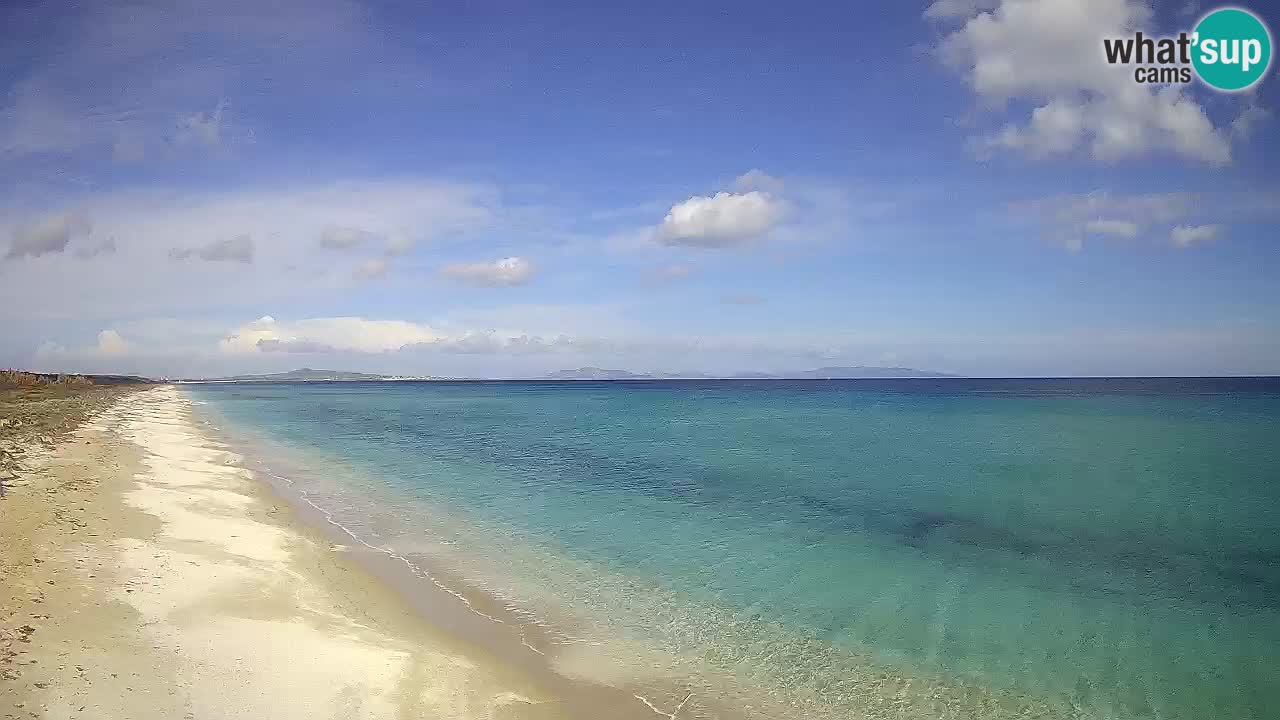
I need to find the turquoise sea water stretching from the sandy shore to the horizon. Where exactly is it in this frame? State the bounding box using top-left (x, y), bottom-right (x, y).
top-left (187, 379), bottom-right (1280, 719)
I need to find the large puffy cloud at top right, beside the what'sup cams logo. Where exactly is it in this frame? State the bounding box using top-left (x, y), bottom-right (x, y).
top-left (925, 0), bottom-right (1231, 165)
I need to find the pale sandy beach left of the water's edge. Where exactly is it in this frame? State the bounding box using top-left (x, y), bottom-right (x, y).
top-left (0, 387), bottom-right (680, 720)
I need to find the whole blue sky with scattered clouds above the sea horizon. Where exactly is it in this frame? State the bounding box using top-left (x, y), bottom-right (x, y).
top-left (0, 0), bottom-right (1280, 377)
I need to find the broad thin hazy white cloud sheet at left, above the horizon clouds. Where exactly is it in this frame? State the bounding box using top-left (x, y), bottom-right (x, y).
top-left (0, 178), bottom-right (503, 322)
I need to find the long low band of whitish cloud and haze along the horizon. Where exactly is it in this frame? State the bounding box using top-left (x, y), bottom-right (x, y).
top-left (22, 306), bottom-right (1280, 377)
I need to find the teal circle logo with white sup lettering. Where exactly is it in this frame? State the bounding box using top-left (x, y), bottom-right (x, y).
top-left (1192, 8), bottom-right (1271, 92)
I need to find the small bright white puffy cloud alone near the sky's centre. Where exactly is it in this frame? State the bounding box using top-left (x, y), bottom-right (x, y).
top-left (657, 190), bottom-right (786, 247)
